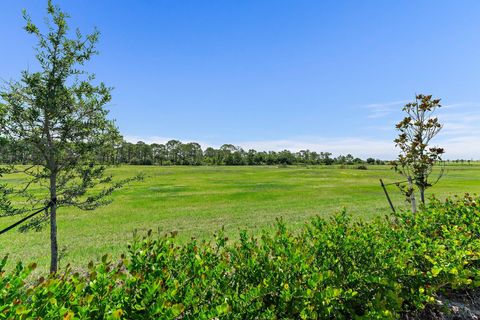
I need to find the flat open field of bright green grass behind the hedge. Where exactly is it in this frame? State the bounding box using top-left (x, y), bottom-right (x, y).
top-left (0, 163), bottom-right (480, 270)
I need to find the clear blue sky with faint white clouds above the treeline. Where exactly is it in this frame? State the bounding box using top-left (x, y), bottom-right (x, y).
top-left (0, 0), bottom-right (480, 158)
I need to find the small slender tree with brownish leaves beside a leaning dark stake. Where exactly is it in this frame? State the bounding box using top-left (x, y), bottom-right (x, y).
top-left (393, 94), bottom-right (444, 212)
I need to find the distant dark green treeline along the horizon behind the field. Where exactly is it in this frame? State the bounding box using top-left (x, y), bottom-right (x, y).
top-left (0, 140), bottom-right (384, 165)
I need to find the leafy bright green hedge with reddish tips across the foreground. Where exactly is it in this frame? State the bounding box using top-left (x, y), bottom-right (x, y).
top-left (0, 195), bottom-right (480, 319)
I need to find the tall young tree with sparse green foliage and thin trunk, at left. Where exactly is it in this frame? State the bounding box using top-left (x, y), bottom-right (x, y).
top-left (0, 1), bottom-right (133, 272)
